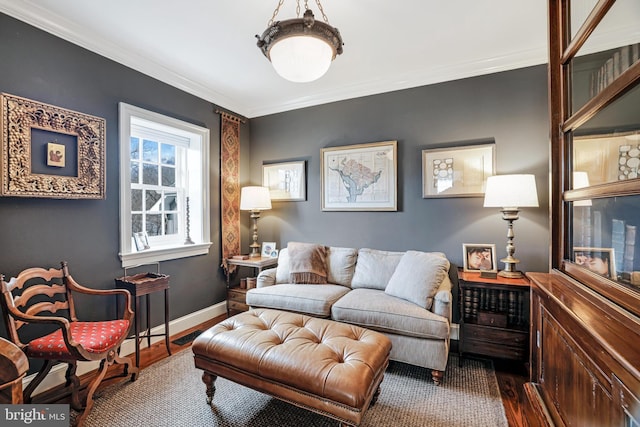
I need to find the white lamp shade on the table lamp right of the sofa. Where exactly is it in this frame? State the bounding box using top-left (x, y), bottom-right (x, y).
top-left (484, 174), bottom-right (538, 208)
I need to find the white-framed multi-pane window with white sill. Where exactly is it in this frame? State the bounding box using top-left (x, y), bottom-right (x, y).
top-left (120, 103), bottom-right (211, 267)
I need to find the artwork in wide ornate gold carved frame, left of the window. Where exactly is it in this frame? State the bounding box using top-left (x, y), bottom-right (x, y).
top-left (0, 93), bottom-right (106, 199)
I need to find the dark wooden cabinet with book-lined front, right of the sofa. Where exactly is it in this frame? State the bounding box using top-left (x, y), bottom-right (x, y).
top-left (458, 270), bottom-right (530, 364)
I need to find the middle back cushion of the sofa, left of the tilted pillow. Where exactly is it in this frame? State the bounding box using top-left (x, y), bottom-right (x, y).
top-left (351, 248), bottom-right (404, 290)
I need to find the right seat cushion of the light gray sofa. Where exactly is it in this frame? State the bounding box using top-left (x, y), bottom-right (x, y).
top-left (332, 289), bottom-right (451, 340)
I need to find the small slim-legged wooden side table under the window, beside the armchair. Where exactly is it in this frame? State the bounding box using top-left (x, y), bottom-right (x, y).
top-left (116, 272), bottom-right (171, 366)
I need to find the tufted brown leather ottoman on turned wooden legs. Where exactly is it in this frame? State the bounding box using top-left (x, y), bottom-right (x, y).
top-left (192, 309), bottom-right (391, 425)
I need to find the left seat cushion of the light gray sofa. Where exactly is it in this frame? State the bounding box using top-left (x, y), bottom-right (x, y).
top-left (247, 284), bottom-right (350, 317)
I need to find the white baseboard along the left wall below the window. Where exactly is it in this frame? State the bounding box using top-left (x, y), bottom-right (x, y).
top-left (22, 302), bottom-right (227, 396)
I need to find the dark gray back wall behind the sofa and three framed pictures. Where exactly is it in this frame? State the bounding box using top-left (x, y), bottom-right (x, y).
top-left (250, 66), bottom-right (549, 288)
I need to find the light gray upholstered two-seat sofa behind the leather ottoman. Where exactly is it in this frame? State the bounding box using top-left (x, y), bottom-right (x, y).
top-left (247, 247), bottom-right (457, 385)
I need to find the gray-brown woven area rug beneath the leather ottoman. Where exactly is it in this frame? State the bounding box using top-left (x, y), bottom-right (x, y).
top-left (85, 349), bottom-right (508, 427)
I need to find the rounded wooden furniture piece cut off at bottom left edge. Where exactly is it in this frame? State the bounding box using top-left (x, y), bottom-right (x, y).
top-left (0, 337), bottom-right (29, 404)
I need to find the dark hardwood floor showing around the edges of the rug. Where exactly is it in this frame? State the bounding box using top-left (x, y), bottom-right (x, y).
top-left (34, 315), bottom-right (528, 427)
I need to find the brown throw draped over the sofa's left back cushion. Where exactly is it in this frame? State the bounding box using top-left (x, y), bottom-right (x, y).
top-left (287, 242), bottom-right (327, 284)
